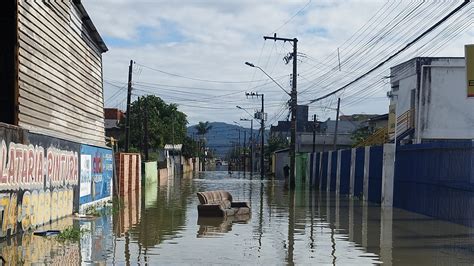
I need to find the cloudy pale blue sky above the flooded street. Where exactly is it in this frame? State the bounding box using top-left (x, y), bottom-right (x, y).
top-left (82, 0), bottom-right (474, 127)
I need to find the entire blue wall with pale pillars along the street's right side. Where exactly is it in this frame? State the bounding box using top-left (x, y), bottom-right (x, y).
top-left (308, 141), bottom-right (474, 226)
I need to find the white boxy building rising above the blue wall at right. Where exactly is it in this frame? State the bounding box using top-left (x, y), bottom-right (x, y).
top-left (391, 58), bottom-right (474, 139)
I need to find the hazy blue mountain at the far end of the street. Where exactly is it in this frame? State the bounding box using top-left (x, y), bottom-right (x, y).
top-left (188, 121), bottom-right (262, 158)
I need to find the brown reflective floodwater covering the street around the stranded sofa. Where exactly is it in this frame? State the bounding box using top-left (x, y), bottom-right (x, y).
top-left (0, 172), bottom-right (474, 265)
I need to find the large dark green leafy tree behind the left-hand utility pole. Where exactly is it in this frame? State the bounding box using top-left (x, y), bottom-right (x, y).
top-left (121, 95), bottom-right (188, 154)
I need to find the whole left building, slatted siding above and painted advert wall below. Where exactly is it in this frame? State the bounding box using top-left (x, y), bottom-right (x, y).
top-left (0, 0), bottom-right (114, 239)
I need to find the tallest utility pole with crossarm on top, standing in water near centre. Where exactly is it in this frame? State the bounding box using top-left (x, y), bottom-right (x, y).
top-left (263, 33), bottom-right (298, 189)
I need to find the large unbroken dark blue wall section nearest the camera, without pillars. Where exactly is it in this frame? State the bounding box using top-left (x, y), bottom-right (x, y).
top-left (394, 141), bottom-right (474, 226)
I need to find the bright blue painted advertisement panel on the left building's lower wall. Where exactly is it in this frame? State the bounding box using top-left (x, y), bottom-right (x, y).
top-left (79, 145), bottom-right (113, 204)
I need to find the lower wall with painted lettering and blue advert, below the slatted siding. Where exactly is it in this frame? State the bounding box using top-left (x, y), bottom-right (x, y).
top-left (0, 123), bottom-right (113, 238)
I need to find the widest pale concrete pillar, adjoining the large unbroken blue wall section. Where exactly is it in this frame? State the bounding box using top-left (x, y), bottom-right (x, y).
top-left (382, 143), bottom-right (395, 207)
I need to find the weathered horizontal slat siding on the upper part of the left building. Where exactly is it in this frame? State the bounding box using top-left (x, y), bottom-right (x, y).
top-left (18, 0), bottom-right (105, 146)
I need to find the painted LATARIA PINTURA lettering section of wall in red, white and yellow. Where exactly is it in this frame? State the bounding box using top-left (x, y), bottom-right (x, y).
top-left (0, 129), bottom-right (80, 238)
